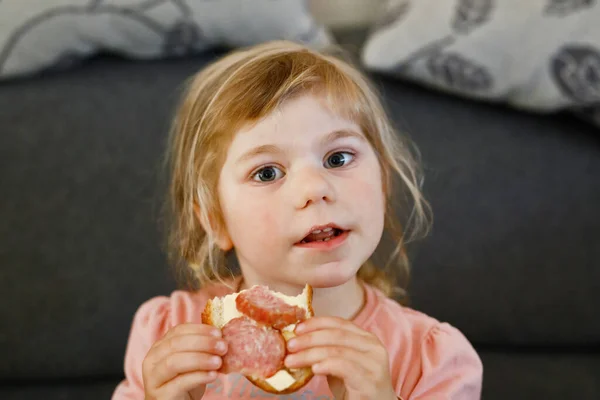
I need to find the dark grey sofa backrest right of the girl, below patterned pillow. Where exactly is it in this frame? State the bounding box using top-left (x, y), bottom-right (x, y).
top-left (379, 74), bottom-right (600, 346)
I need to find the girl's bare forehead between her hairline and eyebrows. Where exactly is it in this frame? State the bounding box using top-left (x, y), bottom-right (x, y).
top-left (230, 95), bottom-right (361, 154)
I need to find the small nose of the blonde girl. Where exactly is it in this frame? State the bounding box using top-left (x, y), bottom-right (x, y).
top-left (292, 168), bottom-right (335, 209)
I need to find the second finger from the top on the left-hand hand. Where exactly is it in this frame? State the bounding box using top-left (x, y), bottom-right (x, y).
top-left (149, 334), bottom-right (227, 362)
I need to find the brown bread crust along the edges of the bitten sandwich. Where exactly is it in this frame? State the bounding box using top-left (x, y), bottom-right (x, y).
top-left (202, 285), bottom-right (315, 394)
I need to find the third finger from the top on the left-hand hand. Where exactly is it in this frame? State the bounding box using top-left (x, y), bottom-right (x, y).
top-left (152, 352), bottom-right (223, 386)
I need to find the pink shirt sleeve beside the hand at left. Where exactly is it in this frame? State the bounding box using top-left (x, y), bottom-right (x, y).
top-left (112, 297), bottom-right (171, 400)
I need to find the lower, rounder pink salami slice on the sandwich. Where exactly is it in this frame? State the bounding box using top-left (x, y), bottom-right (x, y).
top-left (221, 317), bottom-right (285, 379)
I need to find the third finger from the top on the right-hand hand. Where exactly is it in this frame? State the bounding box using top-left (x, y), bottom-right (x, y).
top-left (284, 346), bottom-right (375, 368)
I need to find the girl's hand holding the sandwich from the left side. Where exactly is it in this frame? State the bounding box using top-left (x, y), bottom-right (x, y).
top-left (142, 324), bottom-right (227, 400)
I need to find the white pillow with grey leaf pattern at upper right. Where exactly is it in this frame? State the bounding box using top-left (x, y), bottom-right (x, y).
top-left (362, 0), bottom-right (600, 125)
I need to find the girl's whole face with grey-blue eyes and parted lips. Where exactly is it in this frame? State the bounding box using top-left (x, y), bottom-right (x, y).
top-left (219, 95), bottom-right (385, 288)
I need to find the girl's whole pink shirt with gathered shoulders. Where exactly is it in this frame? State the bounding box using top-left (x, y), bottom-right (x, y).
top-left (112, 285), bottom-right (483, 400)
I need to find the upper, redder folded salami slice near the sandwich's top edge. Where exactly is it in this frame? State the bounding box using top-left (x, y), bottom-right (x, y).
top-left (235, 286), bottom-right (306, 329)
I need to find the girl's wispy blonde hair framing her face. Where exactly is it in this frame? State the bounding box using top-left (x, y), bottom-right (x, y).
top-left (167, 41), bottom-right (429, 297)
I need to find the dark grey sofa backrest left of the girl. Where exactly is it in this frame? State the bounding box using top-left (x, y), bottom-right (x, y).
top-left (0, 54), bottom-right (192, 378)
